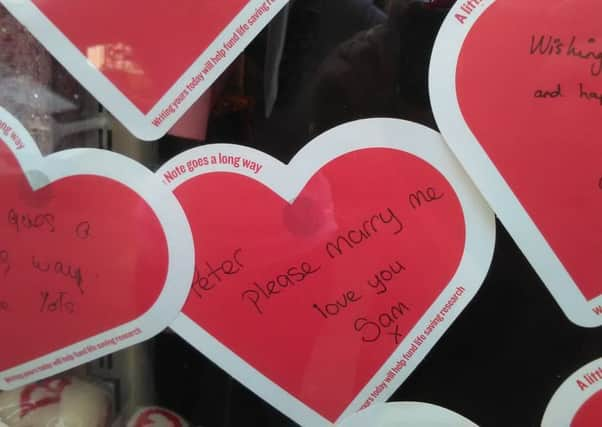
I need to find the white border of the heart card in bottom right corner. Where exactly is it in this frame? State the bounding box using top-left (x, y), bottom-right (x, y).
top-left (541, 358), bottom-right (602, 427)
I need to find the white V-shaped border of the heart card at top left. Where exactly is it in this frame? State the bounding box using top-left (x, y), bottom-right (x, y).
top-left (0, 0), bottom-right (288, 141)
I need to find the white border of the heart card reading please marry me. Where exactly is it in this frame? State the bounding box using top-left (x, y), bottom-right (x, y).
top-left (157, 119), bottom-right (495, 426)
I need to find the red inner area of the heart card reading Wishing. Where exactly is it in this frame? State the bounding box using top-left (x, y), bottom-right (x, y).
top-left (456, 0), bottom-right (602, 300)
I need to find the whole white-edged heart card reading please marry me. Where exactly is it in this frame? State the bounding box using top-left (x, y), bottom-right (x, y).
top-left (157, 119), bottom-right (494, 425)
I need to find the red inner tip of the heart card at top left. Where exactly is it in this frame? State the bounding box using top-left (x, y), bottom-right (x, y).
top-left (33, 0), bottom-right (248, 114)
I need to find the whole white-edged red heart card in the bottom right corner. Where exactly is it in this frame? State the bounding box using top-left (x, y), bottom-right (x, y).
top-left (541, 359), bottom-right (602, 427)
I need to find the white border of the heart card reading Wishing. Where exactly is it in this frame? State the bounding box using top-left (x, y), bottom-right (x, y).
top-left (429, 0), bottom-right (602, 327)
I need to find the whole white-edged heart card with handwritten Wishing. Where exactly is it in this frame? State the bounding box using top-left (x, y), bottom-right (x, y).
top-left (430, 0), bottom-right (602, 327)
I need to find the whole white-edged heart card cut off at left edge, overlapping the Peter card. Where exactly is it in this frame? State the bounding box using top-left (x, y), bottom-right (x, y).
top-left (0, 105), bottom-right (193, 388)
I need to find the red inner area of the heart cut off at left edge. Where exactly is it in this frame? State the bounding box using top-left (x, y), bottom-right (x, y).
top-left (0, 142), bottom-right (168, 371)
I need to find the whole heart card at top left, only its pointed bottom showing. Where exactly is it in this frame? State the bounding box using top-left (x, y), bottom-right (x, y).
top-left (0, 0), bottom-right (287, 139)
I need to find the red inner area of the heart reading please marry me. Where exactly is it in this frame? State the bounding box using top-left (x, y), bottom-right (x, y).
top-left (175, 148), bottom-right (465, 421)
